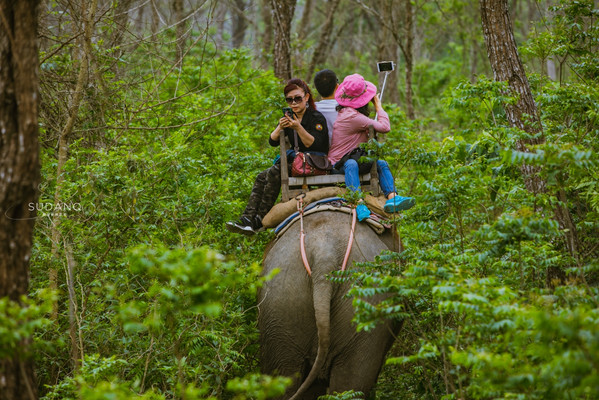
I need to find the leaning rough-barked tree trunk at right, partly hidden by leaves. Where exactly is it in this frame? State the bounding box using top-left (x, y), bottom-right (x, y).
top-left (480, 0), bottom-right (579, 268)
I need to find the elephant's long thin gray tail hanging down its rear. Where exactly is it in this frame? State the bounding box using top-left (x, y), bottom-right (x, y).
top-left (289, 276), bottom-right (333, 400)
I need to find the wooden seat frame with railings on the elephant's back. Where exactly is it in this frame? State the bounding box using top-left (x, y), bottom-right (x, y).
top-left (279, 125), bottom-right (380, 202)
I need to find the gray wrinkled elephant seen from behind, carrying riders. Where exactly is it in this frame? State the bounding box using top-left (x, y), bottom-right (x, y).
top-left (258, 211), bottom-right (401, 400)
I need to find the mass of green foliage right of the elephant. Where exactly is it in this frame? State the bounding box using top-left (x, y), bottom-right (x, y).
top-left (346, 6), bottom-right (599, 399)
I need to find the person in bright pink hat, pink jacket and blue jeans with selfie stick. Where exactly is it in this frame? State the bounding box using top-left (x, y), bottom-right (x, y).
top-left (329, 74), bottom-right (415, 221)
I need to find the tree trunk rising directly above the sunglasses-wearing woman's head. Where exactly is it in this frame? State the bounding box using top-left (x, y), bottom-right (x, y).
top-left (270, 0), bottom-right (295, 80)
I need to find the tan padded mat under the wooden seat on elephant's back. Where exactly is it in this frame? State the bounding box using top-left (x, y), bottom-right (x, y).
top-left (262, 187), bottom-right (391, 228)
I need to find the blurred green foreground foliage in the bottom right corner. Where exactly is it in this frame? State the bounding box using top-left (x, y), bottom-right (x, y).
top-left (452, 294), bottom-right (599, 399)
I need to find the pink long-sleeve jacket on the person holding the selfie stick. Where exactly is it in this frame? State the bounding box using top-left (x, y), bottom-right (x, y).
top-left (329, 107), bottom-right (391, 165)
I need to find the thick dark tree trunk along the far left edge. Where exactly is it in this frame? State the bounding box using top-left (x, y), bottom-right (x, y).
top-left (0, 0), bottom-right (40, 400)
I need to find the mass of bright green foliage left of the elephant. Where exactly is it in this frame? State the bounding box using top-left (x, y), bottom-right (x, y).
top-left (32, 39), bottom-right (282, 399)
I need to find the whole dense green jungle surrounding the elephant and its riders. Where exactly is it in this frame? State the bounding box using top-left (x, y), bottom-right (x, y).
top-left (0, 0), bottom-right (599, 400)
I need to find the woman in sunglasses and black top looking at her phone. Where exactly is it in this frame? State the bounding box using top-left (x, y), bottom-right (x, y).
top-left (225, 79), bottom-right (329, 235)
